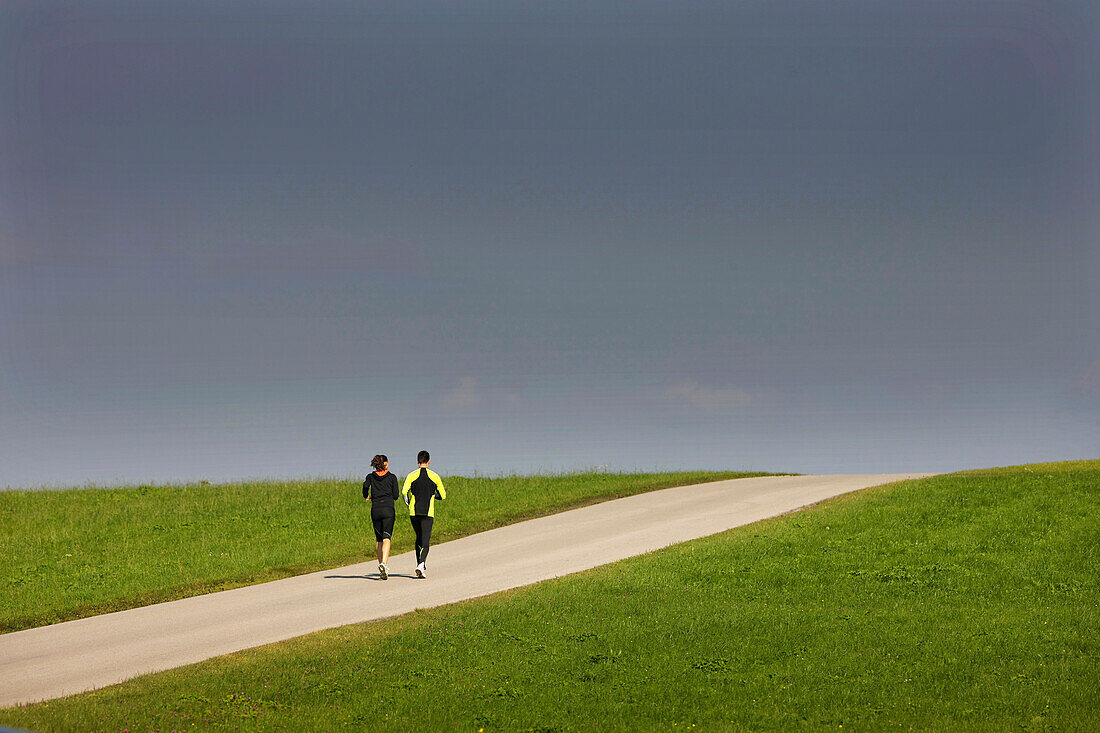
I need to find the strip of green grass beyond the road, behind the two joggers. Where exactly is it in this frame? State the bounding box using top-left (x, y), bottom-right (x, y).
top-left (0, 471), bottom-right (774, 632)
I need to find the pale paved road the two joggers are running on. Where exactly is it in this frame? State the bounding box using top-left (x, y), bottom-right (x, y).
top-left (0, 473), bottom-right (925, 707)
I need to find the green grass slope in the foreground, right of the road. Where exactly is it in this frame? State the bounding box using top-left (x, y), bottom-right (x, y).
top-left (0, 461), bottom-right (1100, 731)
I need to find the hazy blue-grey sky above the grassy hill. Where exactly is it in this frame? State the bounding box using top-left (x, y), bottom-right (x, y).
top-left (0, 0), bottom-right (1100, 486)
